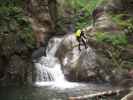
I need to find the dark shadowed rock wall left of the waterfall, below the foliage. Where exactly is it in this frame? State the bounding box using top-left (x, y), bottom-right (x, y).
top-left (0, 33), bottom-right (32, 84)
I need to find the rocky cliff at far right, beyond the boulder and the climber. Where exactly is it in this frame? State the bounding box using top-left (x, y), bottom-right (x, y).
top-left (83, 0), bottom-right (133, 85)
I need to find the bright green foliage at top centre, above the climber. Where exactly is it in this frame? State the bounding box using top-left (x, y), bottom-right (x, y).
top-left (72, 0), bottom-right (103, 29)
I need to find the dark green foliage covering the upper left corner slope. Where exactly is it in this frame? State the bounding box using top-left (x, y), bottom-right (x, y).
top-left (0, 0), bottom-right (35, 47)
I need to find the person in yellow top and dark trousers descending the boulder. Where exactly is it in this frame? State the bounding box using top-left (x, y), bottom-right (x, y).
top-left (75, 29), bottom-right (87, 51)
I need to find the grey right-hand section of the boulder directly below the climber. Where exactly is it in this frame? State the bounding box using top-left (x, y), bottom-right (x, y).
top-left (72, 47), bottom-right (97, 81)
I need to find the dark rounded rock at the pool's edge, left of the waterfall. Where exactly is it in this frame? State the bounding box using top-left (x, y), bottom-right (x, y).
top-left (3, 55), bottom-right (32, 85)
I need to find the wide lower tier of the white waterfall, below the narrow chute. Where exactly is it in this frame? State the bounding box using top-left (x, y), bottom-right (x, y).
top-left (35, 56), bottom-right (65, 82)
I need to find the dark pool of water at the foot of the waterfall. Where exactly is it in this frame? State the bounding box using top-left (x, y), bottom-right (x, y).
top-left (0, 84), bottom-right (123, 100)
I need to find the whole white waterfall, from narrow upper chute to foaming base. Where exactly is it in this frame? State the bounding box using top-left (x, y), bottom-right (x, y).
top-left (34, 38), bottom-right (77, 88)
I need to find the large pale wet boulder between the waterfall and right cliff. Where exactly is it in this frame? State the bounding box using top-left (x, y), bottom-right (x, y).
top-left (56, 34), bottom-right (97, 81)
